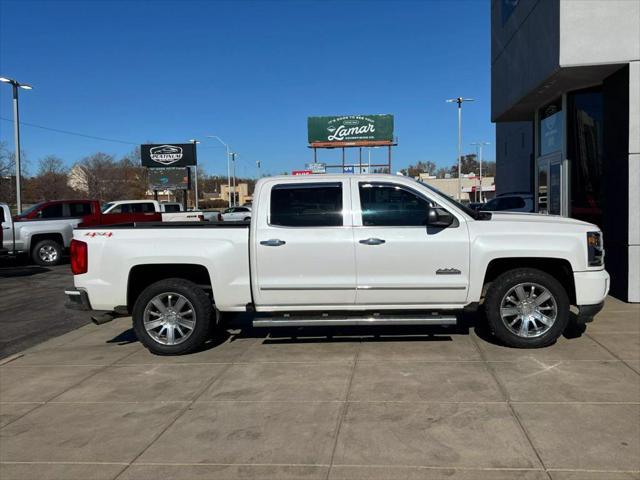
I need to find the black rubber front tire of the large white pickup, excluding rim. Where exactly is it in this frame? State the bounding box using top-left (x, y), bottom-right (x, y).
top-left (484, 268), bottom-right (569, 348)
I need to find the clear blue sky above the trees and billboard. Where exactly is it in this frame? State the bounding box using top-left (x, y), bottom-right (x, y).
top-left (0, 0), bottom-right (495, 176)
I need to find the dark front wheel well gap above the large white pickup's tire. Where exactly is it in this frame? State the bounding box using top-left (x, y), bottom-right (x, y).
top-left (483, 257), bottom-right (576, 305)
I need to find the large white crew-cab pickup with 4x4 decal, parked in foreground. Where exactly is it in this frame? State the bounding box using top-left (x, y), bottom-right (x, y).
top-left (65, 175), bottom-right (609, 354)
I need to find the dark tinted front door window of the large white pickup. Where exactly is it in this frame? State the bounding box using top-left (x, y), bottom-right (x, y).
top-left (359, 183), bottom-right (429, 227)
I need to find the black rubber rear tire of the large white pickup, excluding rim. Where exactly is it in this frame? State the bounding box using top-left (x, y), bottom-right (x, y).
top-left (132, 278), bottom-right (215, 355)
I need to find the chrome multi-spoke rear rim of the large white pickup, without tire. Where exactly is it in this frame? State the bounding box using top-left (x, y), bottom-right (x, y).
top-left (143, 292), bottom-right (196, 345)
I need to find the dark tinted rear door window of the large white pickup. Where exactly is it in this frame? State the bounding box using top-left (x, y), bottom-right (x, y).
top-left (269, 183), bottom-right (343, 227)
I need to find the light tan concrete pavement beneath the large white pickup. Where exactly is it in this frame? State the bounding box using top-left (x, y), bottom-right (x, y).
top-left (0, 299), bottom-right (640, 480)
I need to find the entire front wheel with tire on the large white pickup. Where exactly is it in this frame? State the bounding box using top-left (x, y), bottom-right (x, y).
top-left (485, 268), bottom-right (569, 348)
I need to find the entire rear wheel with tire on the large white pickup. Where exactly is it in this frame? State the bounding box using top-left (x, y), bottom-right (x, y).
top-left (133, 278), bottom-right (213, 355)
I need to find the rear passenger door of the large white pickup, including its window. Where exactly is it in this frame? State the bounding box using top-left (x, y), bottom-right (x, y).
top-left (251, 180), bottom-right (356, 310)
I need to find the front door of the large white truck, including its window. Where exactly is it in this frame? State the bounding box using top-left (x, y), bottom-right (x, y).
top-left (351, 179), bottom-right (469, 308)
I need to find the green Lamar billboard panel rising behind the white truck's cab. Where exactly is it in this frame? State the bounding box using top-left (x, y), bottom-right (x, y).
top-left (307, 115), bottom-right (393, 147)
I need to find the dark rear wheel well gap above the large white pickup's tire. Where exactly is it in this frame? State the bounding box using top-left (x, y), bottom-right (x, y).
top-left (127, 263), bottom-right (212, 312)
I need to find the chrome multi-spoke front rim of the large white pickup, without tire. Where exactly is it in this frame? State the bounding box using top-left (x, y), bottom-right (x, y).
top-left (500, 283), bottom-right (558, 338)
